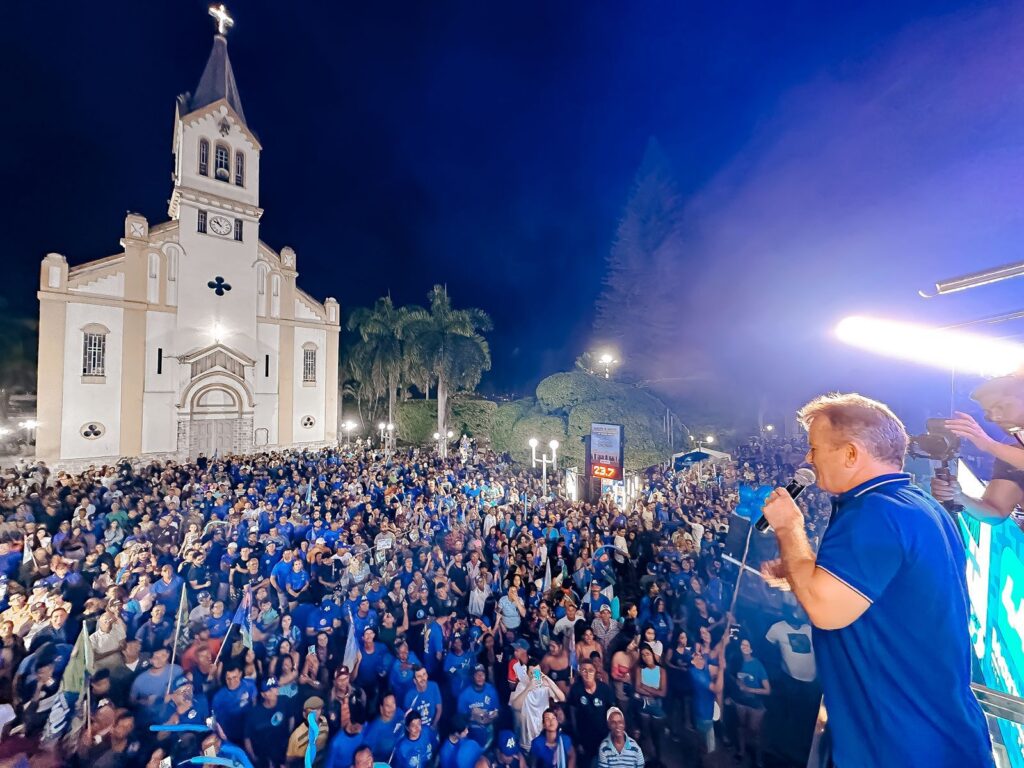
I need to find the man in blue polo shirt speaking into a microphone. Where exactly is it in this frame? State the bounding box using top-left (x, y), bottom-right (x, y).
top-left (764, 394), bottom-right (993, 768)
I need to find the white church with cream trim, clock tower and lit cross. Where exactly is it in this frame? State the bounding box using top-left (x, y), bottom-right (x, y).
top-left (36, 6), bottom-right (341, 466)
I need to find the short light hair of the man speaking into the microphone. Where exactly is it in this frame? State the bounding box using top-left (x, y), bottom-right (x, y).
top-left (797, 392), bottom-right (908, 469)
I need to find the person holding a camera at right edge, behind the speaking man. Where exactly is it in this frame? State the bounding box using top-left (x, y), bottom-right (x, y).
top-left (931, 376), bottom-right (1024, 523)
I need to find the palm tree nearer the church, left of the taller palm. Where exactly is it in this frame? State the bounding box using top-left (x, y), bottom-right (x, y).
top-left (348, 296), bottom-right (417, 423)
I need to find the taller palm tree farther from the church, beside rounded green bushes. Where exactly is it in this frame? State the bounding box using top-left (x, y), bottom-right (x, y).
top-left (407, 286), bottom-right (493, 434)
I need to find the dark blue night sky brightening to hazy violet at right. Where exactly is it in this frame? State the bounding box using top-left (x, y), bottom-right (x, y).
top-left (0, 0), bottom-right (1024, 409)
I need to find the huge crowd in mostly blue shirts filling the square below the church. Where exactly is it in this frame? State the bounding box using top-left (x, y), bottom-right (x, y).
top-left (0, 438), bottom-right (828, 768)
